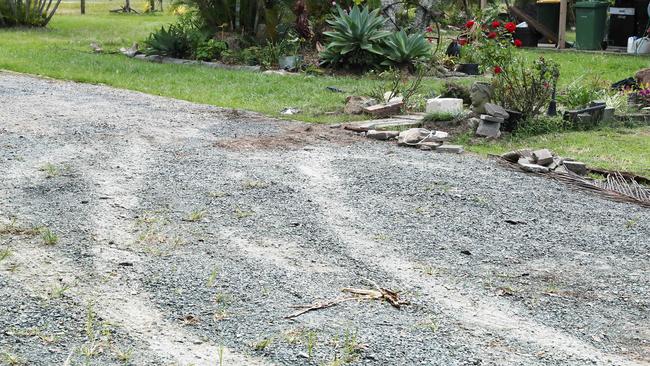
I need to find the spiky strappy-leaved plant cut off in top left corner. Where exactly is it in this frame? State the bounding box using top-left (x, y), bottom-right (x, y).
top-left (0, 0), bottom-right (61, 28)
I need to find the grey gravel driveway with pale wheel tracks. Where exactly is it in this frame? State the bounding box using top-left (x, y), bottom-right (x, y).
top-left (0, 73), bottom-right (650, 366)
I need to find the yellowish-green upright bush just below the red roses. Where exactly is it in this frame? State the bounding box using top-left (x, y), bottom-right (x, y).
top-left (492, 57), bottom-right (560, 119)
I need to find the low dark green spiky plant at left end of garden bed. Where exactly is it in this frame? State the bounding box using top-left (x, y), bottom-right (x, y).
top-left (145, 24), bottom-right (192, 58)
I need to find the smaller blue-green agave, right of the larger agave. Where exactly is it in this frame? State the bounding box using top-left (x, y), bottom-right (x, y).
top-left (382, 30), bottom-right (431, 67)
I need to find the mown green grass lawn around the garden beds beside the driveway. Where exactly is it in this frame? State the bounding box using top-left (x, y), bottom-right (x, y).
top-left (0, 0), bottom-right (650, 172)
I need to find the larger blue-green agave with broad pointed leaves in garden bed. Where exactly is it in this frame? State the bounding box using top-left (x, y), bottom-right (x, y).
top-left (321, 5), bottom-right (390, 69)
